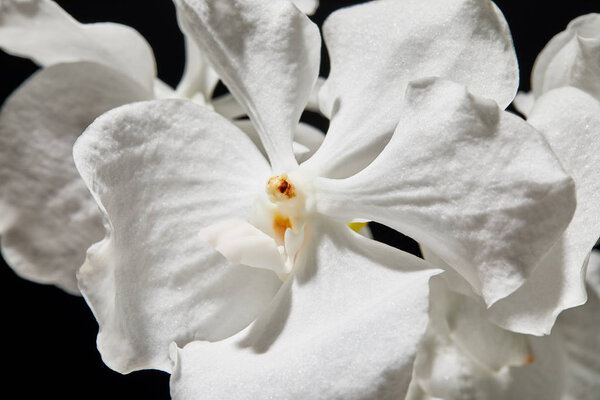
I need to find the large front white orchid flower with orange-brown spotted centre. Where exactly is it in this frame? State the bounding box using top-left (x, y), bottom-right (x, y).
top-left (74, 0), bottom-right (574, 399)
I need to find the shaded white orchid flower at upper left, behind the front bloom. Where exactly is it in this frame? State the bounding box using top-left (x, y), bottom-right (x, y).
top-left (0, 0), bottom-right (323, 294)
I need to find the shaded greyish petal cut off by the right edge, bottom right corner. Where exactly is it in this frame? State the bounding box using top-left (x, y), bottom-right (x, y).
top-left (553, 251), bottom-right (600, 400)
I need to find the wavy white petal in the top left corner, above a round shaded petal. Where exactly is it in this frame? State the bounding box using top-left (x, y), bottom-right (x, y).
top-left (0, 0), bottom-right (156, 91)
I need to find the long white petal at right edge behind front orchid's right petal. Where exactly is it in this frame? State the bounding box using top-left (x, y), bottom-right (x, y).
top-left (490, 88), bottom-right (600, 335)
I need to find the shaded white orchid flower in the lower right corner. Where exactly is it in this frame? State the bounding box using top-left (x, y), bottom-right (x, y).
top-left (406, 251), bottom-right (600, 400)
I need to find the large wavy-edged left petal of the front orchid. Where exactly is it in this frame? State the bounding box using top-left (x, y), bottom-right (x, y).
top-left (74, 100), bottom-right (281, 372)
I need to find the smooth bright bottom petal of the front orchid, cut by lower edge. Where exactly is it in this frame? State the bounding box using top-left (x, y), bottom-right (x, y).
top-left (171, 221), bottom-right (435, 400)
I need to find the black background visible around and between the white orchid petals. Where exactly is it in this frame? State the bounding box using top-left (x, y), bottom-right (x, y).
top-left (0, 0), bottom-right (600, 399)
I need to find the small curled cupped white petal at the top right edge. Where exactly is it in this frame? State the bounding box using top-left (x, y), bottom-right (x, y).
top-left (531, 14), bottom-right (600, 100)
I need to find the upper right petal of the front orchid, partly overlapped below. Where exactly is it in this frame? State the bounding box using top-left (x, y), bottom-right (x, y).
top-left (311, 0), bottom-right (519, 177)
